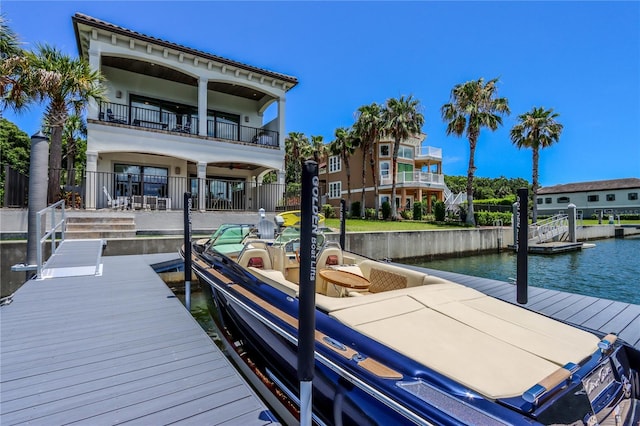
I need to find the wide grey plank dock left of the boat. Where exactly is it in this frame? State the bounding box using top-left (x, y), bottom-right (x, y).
top-left (0, 254), bottom-right (274, 425)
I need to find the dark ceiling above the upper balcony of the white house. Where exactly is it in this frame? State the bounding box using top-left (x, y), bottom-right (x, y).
top-left (102, 56), bottom-right (272, 101)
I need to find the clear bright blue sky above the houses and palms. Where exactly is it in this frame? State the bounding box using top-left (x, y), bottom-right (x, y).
top-left (2, 0), bottom-right (640, 186)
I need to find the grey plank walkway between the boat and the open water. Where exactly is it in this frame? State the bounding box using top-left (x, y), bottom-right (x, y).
top-left (420, 266), bottom-right (640, 349)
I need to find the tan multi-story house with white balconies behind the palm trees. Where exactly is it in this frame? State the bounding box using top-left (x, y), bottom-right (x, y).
top-left (321, 134), bottom-right (446, 211)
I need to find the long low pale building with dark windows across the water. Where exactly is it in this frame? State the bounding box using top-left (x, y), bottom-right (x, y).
top-left (536, 178), bottom-right (640, 218)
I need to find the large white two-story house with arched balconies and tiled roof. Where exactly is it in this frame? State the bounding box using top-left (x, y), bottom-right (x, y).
top-left (72, 14), bottom-right (298, 210)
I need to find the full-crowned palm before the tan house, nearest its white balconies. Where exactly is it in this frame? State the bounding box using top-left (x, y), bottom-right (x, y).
top-left (382, 95), bottom-right (424, 218)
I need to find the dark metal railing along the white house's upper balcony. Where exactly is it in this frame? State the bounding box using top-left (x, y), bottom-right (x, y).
top-left (98, 102), bottom-right (279, 147)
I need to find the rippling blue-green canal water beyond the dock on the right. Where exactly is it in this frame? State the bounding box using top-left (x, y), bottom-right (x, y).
top-left (404, 237), bottom-right (640, 305)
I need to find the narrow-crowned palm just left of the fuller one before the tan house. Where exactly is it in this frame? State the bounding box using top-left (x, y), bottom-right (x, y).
top-left (354, 102), bottom-right (382, 217)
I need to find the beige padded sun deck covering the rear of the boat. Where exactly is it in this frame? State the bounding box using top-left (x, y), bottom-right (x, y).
top-left (329, 283), bottom-right (599, 399)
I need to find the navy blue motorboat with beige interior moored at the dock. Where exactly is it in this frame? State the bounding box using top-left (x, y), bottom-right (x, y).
top-left (183, 228), bottom-right (640, 425)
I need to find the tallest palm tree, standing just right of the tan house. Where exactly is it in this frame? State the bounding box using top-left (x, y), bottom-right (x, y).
top-left (441, 78), bottom-right (511, 226)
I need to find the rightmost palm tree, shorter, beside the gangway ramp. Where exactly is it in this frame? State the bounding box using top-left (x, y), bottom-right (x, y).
top-left (511, 107), bottom-right (563, 223)
